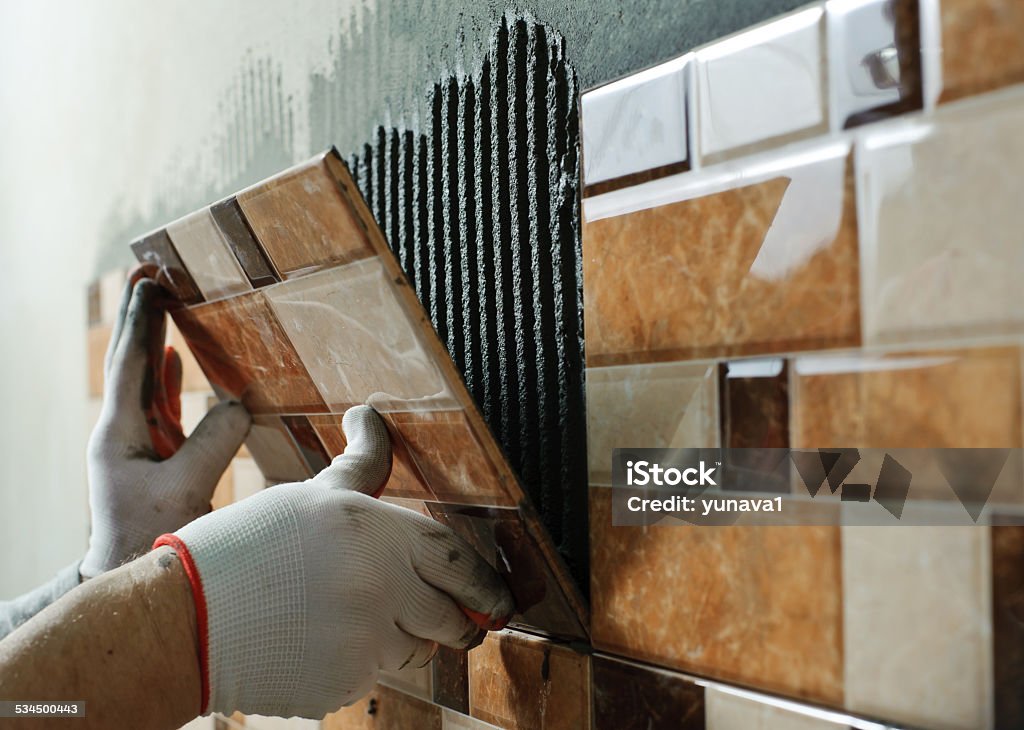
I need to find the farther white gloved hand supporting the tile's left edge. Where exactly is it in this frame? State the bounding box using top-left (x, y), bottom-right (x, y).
top-left (79, 275), bottom-right (251, 578)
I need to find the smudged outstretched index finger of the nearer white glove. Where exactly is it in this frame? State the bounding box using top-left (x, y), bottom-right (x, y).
top-left (404, 511), bottom-right (515, 628)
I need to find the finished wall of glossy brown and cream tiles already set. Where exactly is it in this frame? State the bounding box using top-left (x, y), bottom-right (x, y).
top-left (89, 0), bottom-right (1024, 730)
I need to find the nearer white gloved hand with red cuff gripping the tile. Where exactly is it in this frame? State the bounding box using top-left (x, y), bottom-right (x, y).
top-left (154, 406), bottom-right (514, 719)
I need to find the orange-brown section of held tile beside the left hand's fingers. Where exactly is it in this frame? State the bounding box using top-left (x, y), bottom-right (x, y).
top-left (174, 292), bottom-right (327, 414)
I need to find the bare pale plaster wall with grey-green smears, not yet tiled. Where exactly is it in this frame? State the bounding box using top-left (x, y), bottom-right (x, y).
top-left (0, 0), bottom-right (799, 596)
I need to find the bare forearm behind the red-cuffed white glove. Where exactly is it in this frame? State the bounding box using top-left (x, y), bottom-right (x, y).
top-left (0, 548), bottom-right (201, 730)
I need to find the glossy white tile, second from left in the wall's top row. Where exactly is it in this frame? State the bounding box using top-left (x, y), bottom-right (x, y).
top-left (696, 7), bottom-right (827, 161)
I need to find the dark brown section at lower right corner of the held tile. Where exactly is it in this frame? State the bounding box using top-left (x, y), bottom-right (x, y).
top-left (427, 503), bottom-right (586, 638)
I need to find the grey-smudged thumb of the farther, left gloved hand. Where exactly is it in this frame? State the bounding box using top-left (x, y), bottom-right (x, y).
top-left (167, 401), bottom-right (252, 502)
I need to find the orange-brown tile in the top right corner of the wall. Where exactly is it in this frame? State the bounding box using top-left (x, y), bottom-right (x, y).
top-left (941, 0), bottom-right (1024, 101)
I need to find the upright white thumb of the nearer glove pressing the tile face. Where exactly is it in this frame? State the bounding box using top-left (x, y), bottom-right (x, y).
top-left (316, 405), bottom-right (391, 497)
